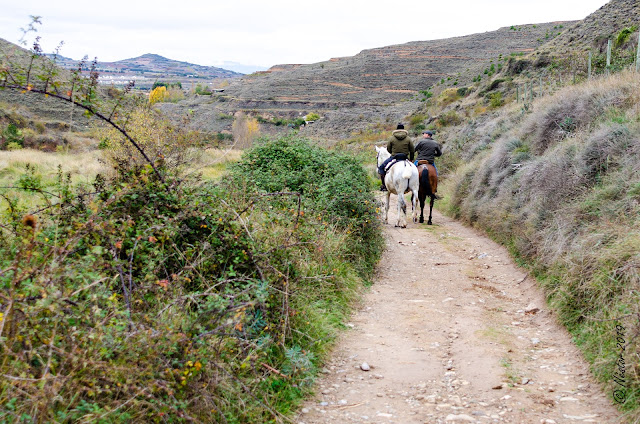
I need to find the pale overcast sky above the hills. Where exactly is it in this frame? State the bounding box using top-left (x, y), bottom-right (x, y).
top-left (0, 0), bottom-right (607, 71)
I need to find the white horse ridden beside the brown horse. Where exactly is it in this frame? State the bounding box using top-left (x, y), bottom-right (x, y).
top-left (376, 146), bottom-right (420, 228)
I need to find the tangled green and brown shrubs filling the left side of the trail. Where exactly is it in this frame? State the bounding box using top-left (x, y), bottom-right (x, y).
top-left (0, 138), bottom-right (382, 423)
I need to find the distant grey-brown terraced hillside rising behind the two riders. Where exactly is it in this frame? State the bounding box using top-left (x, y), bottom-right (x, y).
top-left (162, 21), bottom-right (575, 140)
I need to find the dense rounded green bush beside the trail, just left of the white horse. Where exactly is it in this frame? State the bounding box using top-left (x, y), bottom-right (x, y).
top-left (233, 136), bottom-right (382, 275)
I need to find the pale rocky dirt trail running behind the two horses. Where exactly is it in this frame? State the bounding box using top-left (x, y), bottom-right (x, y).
top-left (294, 196), bottom-right (623, 424)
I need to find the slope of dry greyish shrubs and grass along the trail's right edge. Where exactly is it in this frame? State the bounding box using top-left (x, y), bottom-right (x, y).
top-left (445, 73), bottom-right (640, 419)
